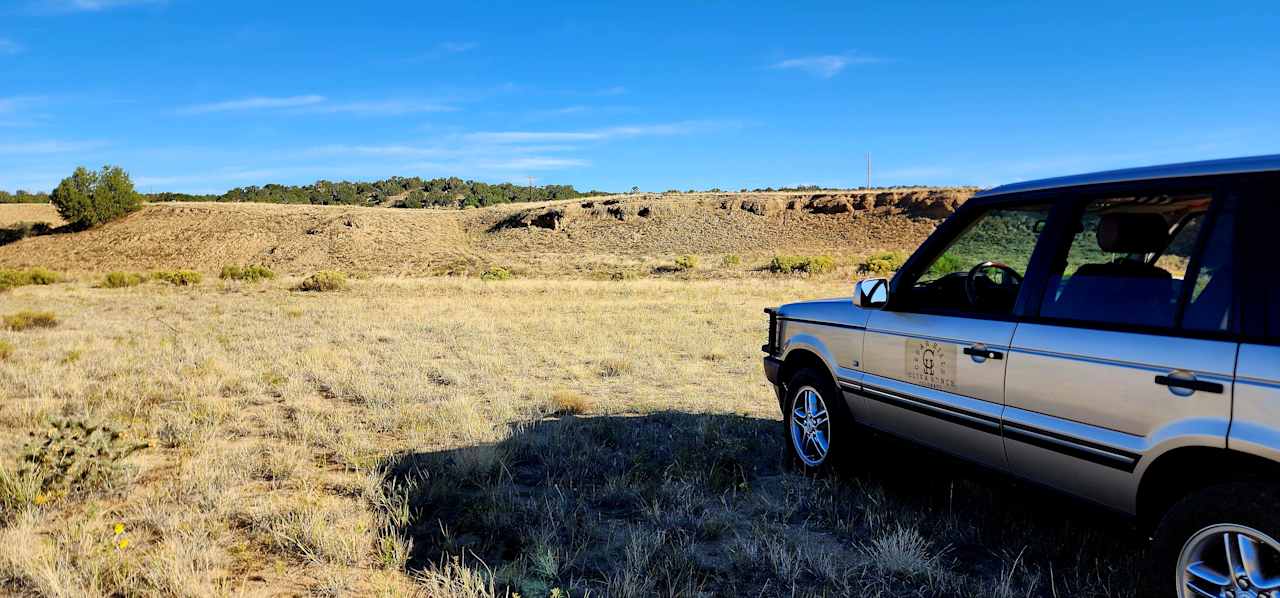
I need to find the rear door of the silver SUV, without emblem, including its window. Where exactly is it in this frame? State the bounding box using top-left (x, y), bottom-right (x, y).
top-left (1004, 190), bottom-right (1236, 511)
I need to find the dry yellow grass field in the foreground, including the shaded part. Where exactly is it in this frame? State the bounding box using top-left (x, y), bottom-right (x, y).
top-left (0, 274), bottom-right (1140, 597)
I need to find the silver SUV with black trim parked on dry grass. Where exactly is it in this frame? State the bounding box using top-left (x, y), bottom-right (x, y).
top-left (764, 155), bottom-right (1280, 598)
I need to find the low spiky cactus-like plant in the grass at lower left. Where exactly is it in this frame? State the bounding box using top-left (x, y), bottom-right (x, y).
top-left (19, 419), bottom-right (146, 493)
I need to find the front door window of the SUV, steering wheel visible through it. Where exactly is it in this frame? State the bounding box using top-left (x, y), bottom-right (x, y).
top-left (900, 205), bottom-right (1051, 315)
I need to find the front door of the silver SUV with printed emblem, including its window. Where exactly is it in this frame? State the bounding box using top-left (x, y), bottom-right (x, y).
top-left (858, 204), bottom-right (1050, 469)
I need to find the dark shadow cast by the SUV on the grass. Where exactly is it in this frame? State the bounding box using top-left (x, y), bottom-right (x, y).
top-left (385, 412), bottom-right (1142, 597)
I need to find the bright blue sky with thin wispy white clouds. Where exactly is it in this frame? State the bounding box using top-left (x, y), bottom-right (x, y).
top-left (0, 0), bottom-right (1280, 192)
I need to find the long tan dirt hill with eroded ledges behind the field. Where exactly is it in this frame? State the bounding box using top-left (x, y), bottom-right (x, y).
top-left (0, 188), bottom-right (973, 275)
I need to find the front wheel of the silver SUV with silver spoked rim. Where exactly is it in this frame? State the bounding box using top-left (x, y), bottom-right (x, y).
top-left (782, 368), bottom-right (858, 474)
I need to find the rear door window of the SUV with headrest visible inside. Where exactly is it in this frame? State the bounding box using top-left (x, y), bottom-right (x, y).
top-left (1041, 193), bottom-right (1234, 330)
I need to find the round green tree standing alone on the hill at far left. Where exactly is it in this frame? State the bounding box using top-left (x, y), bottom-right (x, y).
top-left (49, 165), bottom-right (142, 229)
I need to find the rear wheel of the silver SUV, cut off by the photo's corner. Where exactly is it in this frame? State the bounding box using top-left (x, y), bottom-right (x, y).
top-left (1140, 481), bottom-right (1280, 598)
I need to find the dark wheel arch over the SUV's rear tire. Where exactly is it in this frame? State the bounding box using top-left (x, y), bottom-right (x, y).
top-left (1135, 447), bottom-right (1280, 531)
